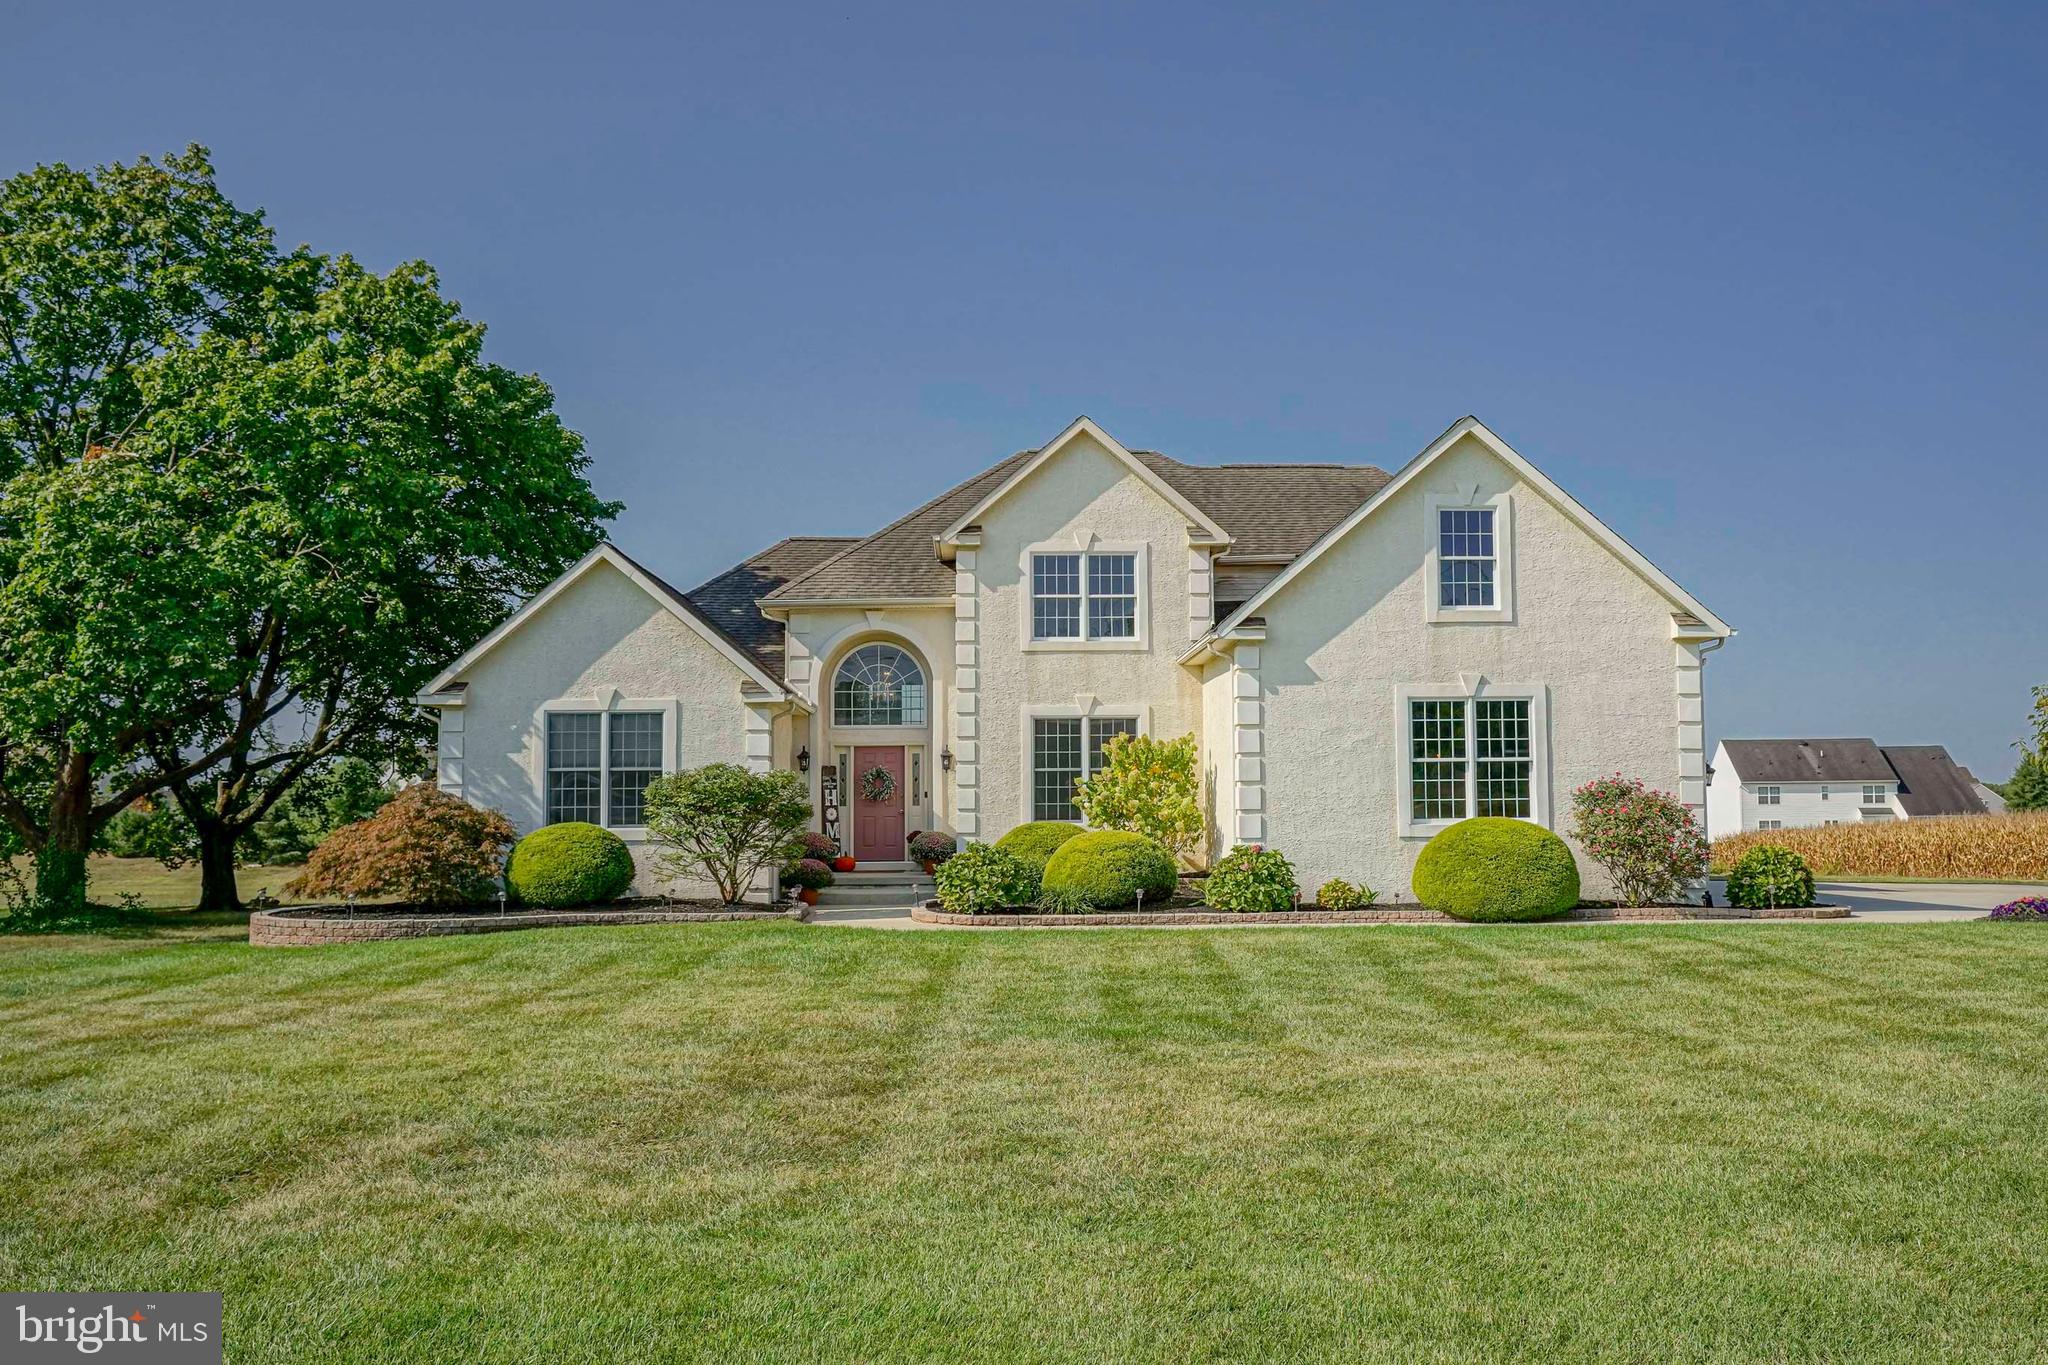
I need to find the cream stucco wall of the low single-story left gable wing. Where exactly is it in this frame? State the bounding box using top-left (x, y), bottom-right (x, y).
top-left (440, 561), bottom-right (788, 896)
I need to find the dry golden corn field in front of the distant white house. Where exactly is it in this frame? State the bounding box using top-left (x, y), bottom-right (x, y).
top-left (1714, 810), bottom-right (2048, 882)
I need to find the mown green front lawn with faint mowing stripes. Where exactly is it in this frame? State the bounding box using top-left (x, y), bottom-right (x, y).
top-left (0, 923), bottom-right (2048, 1363)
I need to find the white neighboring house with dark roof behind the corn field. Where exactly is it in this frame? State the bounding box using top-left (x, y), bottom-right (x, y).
top-left (1706, 739), bottom-right (2003, 837)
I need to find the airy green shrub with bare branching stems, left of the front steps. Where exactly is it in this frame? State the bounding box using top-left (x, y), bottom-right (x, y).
top-left (647, 763), bottom-right (811, 905)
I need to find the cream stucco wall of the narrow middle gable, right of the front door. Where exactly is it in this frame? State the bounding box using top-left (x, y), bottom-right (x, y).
top-left (956, 436), bottom-right (1208, 841)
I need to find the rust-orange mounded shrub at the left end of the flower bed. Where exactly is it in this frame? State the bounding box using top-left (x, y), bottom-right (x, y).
top-left (285, 782), bottom-right (514, 905)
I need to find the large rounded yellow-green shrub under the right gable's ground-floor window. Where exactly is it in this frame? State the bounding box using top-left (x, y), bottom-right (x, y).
top-left (1415, 817), bottom-right (1579, 923)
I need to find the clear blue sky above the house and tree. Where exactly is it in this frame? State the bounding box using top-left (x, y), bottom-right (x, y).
top-left (0, 0), bottom-right (2048, 778)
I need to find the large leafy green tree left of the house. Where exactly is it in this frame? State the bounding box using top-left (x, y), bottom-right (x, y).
top-left (0, 147), bottom-right (616, 913)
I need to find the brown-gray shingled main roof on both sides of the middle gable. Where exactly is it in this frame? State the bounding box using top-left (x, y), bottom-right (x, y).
top-left (774, 450), bottom-right (1389, 600)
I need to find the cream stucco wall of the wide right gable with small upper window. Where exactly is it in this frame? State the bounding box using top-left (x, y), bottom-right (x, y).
top-left (1241, 438), bottom-right (1686, 898)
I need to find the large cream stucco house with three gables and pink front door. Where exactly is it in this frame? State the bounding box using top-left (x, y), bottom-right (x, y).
top-left (420, 417), bottom-right (1733, 896)
